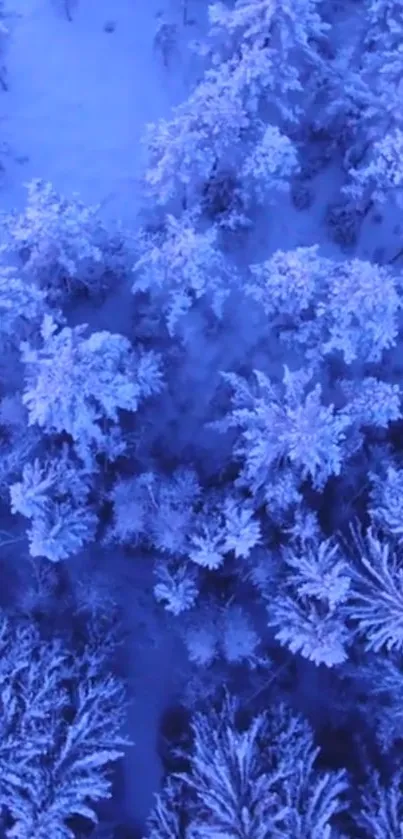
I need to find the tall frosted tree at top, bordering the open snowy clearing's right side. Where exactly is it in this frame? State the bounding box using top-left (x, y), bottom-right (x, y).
top-left (145, 0), bottom-right (327, 206)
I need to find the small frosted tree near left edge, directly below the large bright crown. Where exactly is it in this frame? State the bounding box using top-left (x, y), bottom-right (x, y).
top-left (10, 446), bottom-right (98, 562)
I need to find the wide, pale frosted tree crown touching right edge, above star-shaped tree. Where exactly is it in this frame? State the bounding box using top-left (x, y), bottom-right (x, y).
top-left (245, 245), bottom-right (402, 365)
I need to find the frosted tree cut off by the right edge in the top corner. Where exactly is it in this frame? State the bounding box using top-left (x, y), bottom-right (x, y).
top-left (328, 0), bottom-right (403, 199)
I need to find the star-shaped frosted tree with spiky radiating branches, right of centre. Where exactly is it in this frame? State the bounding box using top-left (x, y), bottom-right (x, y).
top-left (215, 367), bottom-right (350, 502)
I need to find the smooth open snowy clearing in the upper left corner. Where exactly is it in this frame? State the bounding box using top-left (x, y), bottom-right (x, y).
top-left (0, 0), bottom-right (194, 222)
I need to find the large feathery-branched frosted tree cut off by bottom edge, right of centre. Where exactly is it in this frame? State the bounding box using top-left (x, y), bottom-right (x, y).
top-left (150, 697), bottom-right (346, 839)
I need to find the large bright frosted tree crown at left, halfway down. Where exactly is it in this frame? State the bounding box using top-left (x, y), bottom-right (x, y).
top-left (21, 315), bottom-right (162, 465)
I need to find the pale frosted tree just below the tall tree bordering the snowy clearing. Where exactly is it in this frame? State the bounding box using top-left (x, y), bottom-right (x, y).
top-left (132, 214), bottom-right (236, 335)
